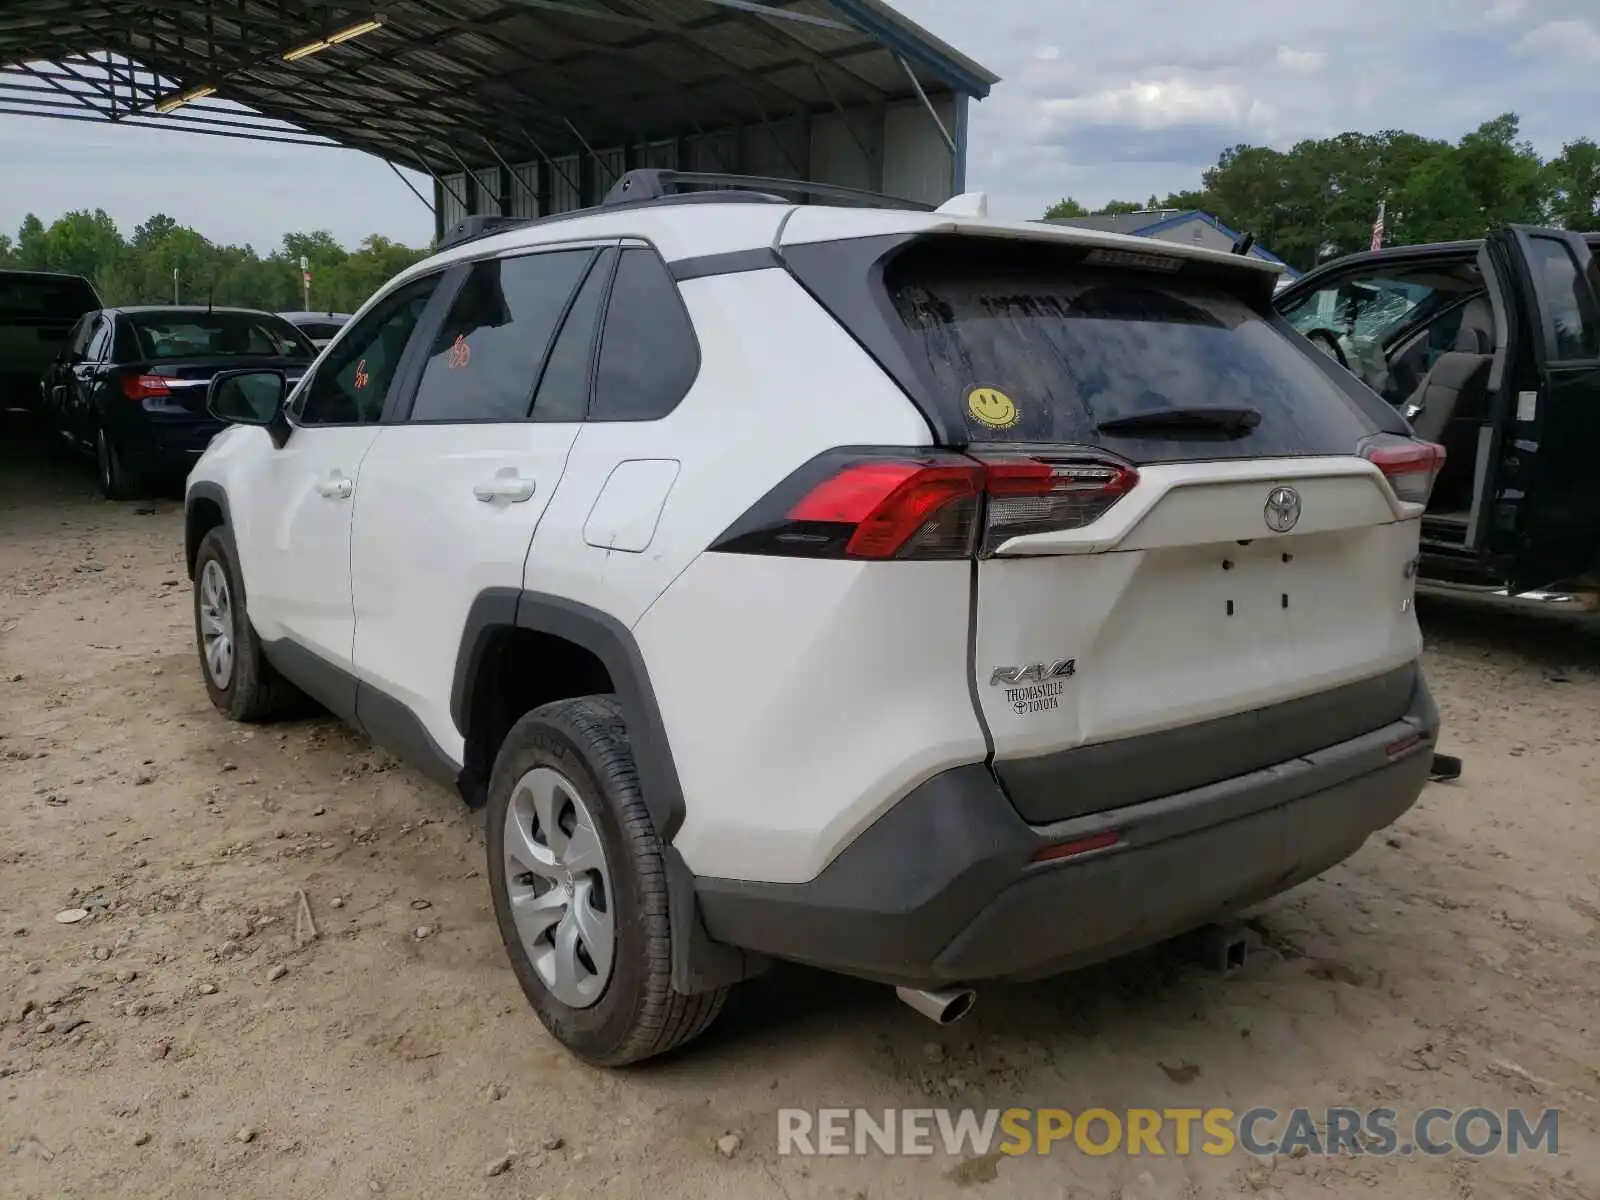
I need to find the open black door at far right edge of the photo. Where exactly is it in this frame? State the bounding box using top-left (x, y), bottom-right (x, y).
top-left (1490, 226), bottom-right (1600, 590)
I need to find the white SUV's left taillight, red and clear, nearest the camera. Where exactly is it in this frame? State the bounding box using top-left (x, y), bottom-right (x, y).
top-left (712, 450), bottom-right (1139, 560)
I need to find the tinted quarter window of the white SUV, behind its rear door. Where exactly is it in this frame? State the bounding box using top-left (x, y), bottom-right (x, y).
top-left (589, 248), bottom-right (699, 421)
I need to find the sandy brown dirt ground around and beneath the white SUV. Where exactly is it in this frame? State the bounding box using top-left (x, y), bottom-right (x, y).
top-left (0, 432), bottom-right (1600, 1200)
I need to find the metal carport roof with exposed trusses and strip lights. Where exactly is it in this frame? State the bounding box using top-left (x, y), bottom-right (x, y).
top-left (0, 0), bottom-right (997, 185)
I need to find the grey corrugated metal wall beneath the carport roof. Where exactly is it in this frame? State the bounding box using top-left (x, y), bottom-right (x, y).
top-left (434, 93), bottom-right (966, 240)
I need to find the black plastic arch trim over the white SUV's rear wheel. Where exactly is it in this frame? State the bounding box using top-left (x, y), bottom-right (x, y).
top-left (450, 587), bottom-right (683, 845)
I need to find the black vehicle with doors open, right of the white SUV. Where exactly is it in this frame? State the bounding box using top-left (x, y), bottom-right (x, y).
top-left (1274, 226), bottom-right (1600, 597)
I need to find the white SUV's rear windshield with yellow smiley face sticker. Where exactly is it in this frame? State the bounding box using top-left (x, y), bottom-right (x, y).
top-left (885, 246), bottom-right (1374, 461)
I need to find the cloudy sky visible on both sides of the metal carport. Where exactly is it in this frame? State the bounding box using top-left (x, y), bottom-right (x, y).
top-left (0, 0), bottom-right (1600, 250)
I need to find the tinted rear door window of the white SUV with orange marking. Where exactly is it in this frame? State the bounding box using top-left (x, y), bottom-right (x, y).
top-left (411, 250), bottom-right (595, 421)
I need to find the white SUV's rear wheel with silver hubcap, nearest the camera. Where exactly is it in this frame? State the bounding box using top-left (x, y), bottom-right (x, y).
top-left (485, 696), bottom-right (728, 1067)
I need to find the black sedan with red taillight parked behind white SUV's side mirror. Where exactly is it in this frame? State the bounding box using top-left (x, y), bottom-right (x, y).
top-left (45, 307), bottom-right (317, 499)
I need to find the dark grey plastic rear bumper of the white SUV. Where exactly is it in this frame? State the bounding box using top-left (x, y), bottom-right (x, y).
top-left (696, 677), bottom-right (1438, 986)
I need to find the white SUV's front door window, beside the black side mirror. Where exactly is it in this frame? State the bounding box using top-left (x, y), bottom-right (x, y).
top-left (294, 275), bottom-right (438, 426)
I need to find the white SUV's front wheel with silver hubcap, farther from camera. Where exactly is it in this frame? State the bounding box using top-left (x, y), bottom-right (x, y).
top-left (194, 526), bottom-right (304, 725)
